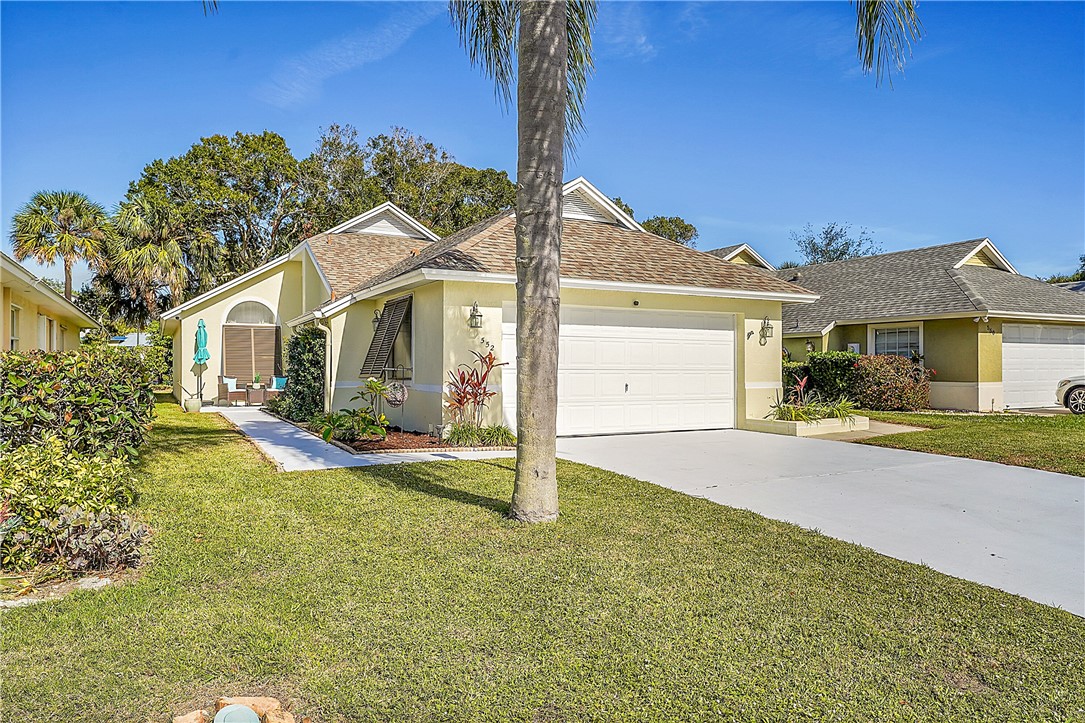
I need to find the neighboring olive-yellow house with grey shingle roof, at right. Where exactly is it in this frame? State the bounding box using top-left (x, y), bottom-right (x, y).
top-left (777, 239), bottom-right (1085, 410)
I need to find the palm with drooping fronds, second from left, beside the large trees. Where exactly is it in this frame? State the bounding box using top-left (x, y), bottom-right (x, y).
top-left (110, 196), bottom-right (190, 329)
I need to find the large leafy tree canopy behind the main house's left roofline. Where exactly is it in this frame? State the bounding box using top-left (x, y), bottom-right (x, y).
top-left (122, 124), bottom-right (515, 297)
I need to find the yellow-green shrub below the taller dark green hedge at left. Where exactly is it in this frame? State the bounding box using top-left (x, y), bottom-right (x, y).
top-left (0, 436), bottom-right (137, 570)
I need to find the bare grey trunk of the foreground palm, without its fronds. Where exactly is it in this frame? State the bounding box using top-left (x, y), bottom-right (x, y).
top-left (509, 1), bottom-right (569, 522)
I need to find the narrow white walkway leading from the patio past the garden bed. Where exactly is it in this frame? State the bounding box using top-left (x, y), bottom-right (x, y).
top-left (218, 407), bottom-right (513, 472)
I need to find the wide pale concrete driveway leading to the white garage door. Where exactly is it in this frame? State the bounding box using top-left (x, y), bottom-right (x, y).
top-left (558, 430), bottom-right (1085, 616)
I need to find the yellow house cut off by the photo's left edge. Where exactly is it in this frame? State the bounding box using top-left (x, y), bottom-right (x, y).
top-left (0, 252), bottom-right (99, 352)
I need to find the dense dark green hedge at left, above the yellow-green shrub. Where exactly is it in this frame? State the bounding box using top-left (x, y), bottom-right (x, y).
top-left (0, 347), bottom-right (154, 455)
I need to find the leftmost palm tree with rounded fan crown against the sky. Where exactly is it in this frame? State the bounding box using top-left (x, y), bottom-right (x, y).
top-left (11, 191), bottom-right (112, 301)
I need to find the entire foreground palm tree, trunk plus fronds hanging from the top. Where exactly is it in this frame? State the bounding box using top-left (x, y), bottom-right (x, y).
top-left (449, 0), bottom-right (920, 522)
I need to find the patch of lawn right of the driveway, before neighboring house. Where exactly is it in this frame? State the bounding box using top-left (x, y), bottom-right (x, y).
top-left (859, 411), bottom-right (1085, 477)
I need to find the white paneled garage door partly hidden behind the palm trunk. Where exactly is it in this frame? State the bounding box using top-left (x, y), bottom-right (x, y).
top-left (501, 306), bottom-right (735, 435)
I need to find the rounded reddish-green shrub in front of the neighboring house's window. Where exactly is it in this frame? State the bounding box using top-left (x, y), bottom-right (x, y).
top-left (848, 354), bottom-right (931, 411)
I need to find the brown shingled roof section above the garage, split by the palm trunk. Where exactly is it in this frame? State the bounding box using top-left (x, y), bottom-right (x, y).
top-left (321, 212), bottom-right (809, 306)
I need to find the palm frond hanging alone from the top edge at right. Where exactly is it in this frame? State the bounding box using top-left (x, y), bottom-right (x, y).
top-left (852, 0), bottom-right (923, 86)
